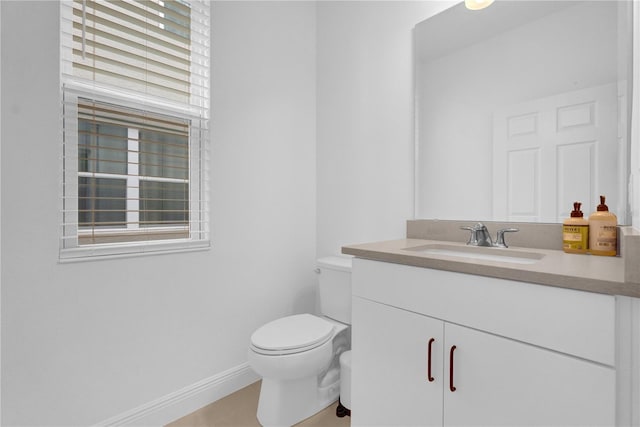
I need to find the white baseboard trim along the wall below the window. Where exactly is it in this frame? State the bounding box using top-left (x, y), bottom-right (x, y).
top-left (94, 363), bottom-right (260, 427)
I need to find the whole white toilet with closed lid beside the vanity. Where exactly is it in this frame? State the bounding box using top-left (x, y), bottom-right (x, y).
top-left (248, 256), bottom-right (351, 426)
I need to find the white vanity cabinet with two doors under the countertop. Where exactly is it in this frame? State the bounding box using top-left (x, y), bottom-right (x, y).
top-left (351, 259), bottom-right (616, 426)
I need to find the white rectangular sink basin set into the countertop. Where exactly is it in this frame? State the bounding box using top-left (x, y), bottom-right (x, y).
top-left (403, 244), bottom-right (544, 264)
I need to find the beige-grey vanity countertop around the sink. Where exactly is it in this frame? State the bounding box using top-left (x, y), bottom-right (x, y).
top-left (342, 238), bottom-right (640, 297)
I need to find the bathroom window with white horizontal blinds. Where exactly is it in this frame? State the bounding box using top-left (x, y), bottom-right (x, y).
top-left (60, 0), bottom-right (210, 260)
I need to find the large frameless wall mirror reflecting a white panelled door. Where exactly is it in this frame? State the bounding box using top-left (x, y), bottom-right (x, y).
top-left (414, 0), bottom-right (632, 224)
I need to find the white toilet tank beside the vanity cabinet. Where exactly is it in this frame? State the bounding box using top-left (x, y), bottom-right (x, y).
top-left (317, 256), bottom-right (353, 325)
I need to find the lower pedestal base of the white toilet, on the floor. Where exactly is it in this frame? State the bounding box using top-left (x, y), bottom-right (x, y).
top-left (257, 376), bottom-right (340, 427)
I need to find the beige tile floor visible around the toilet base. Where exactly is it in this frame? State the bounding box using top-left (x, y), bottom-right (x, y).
top-left (167, 381), bottom-right (351, 427)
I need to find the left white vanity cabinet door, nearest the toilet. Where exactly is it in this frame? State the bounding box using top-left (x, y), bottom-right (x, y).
top-left (351, 297), bottom-right (445, 426)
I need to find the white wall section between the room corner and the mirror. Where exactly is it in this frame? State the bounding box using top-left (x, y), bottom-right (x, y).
top-left (316, 1), bottom-right (454, 256)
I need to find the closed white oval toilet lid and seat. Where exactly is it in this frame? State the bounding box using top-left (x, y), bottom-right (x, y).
top-left (251, 314), bottom-right (334, 354)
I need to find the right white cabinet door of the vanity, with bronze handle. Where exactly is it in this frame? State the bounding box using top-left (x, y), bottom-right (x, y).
top-left (444, 320), bottom-right (616, 426)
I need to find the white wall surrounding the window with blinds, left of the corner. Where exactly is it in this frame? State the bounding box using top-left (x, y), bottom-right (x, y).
top-left (0, 1), bottom-right (316, 426)
